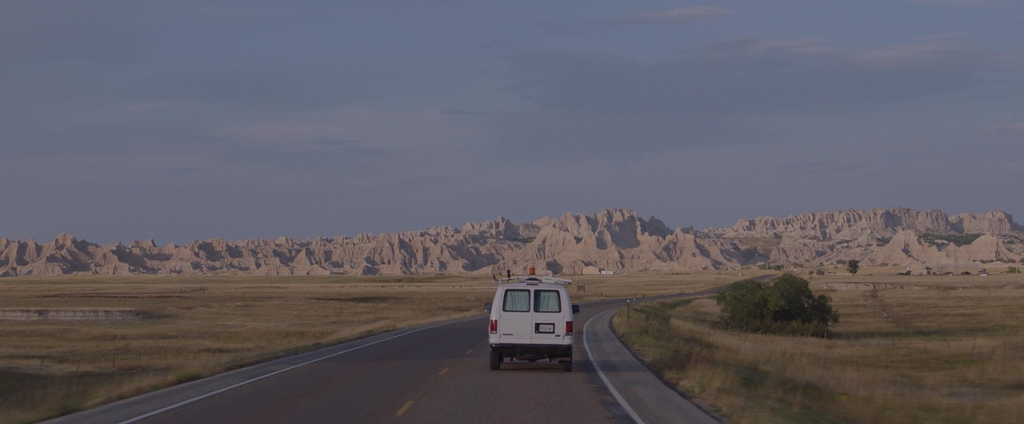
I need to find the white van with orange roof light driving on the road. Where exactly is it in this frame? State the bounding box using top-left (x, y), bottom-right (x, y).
top-left (484, 275), bottom-right (580, 372)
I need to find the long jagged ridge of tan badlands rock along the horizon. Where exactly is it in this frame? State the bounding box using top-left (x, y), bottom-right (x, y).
top-left (0, 208), bottom-right (1024, 277)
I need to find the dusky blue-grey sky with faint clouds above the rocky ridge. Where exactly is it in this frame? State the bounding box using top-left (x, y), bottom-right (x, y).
top-left (0, 0), bottom-right (1024, 243)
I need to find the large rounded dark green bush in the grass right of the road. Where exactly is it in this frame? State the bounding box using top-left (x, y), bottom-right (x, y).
top-left (718, 274), bottom-right (839, 335)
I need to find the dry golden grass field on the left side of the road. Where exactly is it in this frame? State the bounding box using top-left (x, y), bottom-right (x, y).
top-left (0, 272), bottom-right (736, 423)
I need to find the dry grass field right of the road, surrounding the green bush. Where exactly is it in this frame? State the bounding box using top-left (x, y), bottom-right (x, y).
top-left (613, 269), bottom-right (1024, 423)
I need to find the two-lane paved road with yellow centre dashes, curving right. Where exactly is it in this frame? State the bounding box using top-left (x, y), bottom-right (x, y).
top-left (52, 282), bottom-right (745, 423)
